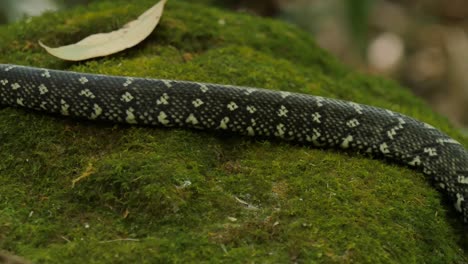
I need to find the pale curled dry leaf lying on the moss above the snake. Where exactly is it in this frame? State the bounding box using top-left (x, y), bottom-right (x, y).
top-left (39, 0), bottom-right (167, 61)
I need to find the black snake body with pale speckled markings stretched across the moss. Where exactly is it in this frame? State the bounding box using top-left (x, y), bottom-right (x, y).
top-left (0, 64), bottom-right (468, 223)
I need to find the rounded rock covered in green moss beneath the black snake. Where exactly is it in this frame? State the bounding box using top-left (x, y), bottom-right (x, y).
top-left (0, 0), bottom-right (468, 263)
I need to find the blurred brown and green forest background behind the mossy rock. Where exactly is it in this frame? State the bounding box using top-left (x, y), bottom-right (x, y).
top-left (0, 0), bottom-right (468, 132)
